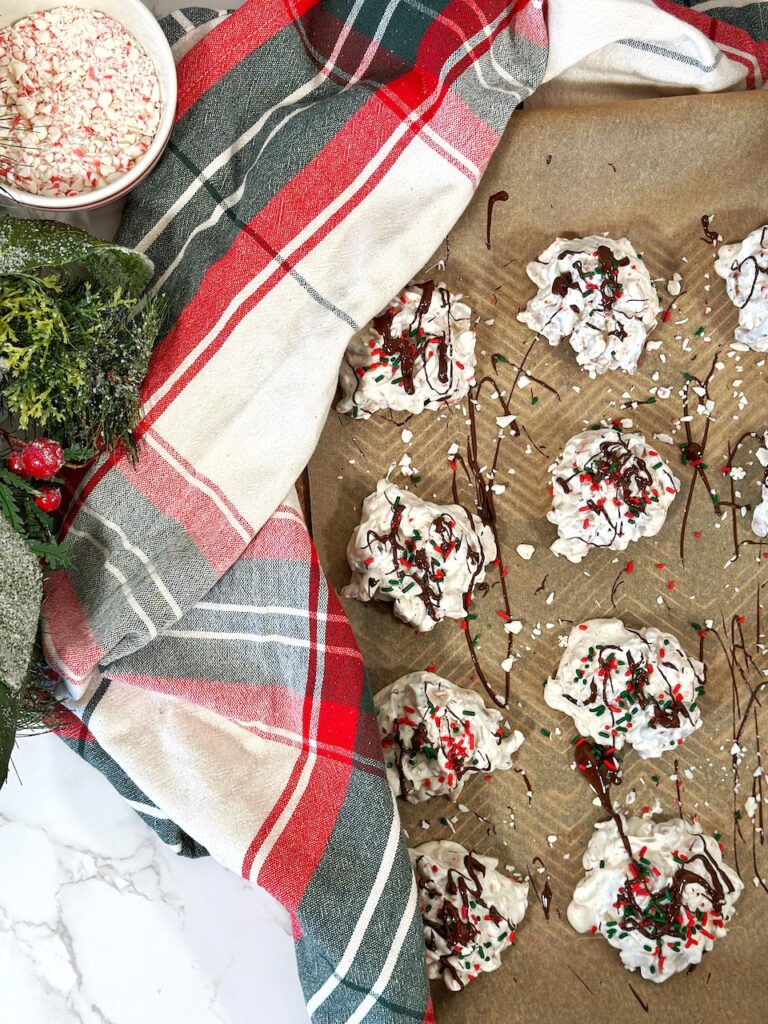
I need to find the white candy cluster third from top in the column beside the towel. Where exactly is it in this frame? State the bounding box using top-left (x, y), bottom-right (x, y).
top-left (375, 672), bottom-right (523, 804)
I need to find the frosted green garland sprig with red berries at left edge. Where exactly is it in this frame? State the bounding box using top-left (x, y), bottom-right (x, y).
top-left (0, 217), bottom-right (166, 785)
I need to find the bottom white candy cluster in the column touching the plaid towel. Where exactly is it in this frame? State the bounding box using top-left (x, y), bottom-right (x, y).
top-left (409, 840), bottom-right (528, 991)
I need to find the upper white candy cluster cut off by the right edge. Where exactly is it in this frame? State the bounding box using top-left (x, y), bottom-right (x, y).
top-left (715, 224), bottom-right (768, 352)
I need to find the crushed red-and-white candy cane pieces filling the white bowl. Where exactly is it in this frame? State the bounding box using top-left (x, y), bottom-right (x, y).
top-left (0, 7), bottom-right (162, 198)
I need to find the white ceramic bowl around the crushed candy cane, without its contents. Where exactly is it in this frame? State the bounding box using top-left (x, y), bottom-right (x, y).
top-left (0, 0), bottom-right (176, 213)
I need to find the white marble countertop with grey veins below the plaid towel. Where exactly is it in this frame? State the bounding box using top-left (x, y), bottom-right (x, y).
top-left (0, 0), bottom-right (307, 1024)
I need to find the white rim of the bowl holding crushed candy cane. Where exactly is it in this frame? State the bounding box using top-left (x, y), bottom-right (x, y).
top-left (0, 0), bottom-right (178, 213)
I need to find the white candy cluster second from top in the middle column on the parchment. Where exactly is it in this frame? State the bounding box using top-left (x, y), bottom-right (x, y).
top-left (547, 427), bottom-right (680, 562)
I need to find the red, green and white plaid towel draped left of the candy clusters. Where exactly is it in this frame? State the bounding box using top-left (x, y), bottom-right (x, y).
top-left (44, 0), bottom-right (546, 1024)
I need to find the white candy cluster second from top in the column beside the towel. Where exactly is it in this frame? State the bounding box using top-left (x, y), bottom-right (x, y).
top-left (342, 479), bottom-right (496, 633)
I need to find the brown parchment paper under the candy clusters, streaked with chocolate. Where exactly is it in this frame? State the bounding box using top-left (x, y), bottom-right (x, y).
top-left (310, 94), bottom-right (768, 1024)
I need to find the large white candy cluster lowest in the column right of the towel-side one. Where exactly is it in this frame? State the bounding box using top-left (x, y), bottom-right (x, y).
top-left (567, 817), bottom-right (743, 982)
